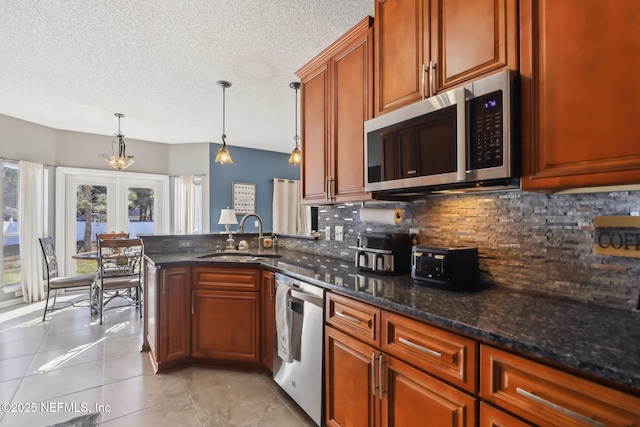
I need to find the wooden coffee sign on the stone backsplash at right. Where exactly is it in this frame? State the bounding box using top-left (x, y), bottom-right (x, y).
top-left (593, 216), bottom-right (640, 258)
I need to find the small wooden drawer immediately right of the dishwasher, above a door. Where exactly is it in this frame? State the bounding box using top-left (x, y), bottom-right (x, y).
top-left (325, 293), bottom-right (380, 346)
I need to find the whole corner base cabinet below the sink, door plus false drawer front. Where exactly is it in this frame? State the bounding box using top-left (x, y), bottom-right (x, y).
top-left (191, 267), bottom-right (261, 364)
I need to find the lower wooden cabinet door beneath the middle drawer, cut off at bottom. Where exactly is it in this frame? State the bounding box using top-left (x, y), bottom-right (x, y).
top-left (379, 354), bottom-right (477, 427)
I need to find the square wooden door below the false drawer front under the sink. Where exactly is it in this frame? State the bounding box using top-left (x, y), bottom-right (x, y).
top-left (191, 289), bottom-right (260, 363)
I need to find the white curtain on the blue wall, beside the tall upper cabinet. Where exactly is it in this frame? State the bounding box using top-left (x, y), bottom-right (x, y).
top-left (272, 178), bottom-right (311, 234)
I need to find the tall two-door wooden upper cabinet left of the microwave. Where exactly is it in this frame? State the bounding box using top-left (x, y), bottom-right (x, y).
top-left (296, 17), bottom-right (373, 204)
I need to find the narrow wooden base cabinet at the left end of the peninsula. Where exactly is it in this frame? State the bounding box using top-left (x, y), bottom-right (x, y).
top-left (144, 263), bottom-right (191, 372)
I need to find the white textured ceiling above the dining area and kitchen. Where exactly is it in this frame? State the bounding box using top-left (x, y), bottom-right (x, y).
top-left (0, 0), bottom-right (374, 152)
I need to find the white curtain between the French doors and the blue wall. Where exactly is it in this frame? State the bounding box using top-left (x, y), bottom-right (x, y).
top-left (173, 175), bottom-right (202, 234)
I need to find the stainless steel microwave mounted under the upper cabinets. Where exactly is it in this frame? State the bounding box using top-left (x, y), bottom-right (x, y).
top-left (364, 70), bottom-right (520, 193)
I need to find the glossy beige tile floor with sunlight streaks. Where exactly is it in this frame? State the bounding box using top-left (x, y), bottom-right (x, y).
top-left (0, 296), bottom-right (315, 427)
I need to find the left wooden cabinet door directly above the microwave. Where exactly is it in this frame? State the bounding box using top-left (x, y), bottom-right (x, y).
top-left (374, 0), bottom-right (430, 116)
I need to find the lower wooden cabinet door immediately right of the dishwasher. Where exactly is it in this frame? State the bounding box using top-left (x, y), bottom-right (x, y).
top-left (325, 326), bottom-right (380, 427)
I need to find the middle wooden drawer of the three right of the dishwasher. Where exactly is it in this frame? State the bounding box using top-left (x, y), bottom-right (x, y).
top-left (382, 312), bottom-right (478, 393)
